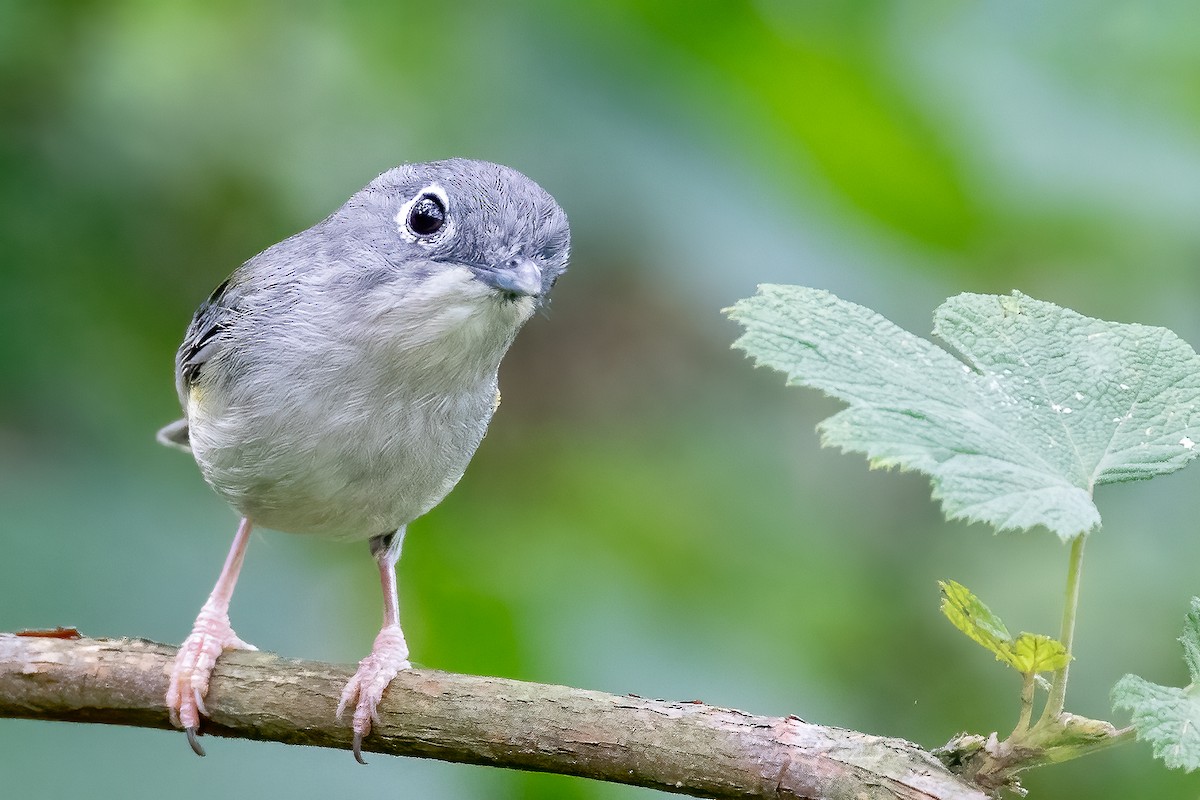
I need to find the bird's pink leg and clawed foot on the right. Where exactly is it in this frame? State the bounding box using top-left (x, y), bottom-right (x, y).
top-left (337, 528), bottom-right (412, 764)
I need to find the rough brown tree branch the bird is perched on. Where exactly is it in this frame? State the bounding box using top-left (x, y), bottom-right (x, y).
top-left (0, 633), bottom-right (988, 800)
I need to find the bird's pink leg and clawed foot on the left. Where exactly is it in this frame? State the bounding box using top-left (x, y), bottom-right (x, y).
top-left (167, 519), bottom-right (258, 756)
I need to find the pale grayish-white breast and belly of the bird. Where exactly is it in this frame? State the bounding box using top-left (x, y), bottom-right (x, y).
top-left (188, 280), bottom-right (522, 539)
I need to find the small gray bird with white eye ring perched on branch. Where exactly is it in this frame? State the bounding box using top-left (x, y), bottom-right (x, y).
top-left (158, 158), bottom-right (570, 762)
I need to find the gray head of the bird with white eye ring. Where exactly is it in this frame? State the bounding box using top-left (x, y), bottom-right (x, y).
top-left (307, 158), bottom-right (570, 376)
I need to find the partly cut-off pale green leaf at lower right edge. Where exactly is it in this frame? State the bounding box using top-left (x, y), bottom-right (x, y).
top-left (1112, 597), bottom-right (1200, 772)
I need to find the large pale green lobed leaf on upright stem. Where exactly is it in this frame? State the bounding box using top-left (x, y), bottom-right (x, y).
top-left (727, 284), bottom-right (1200, 540)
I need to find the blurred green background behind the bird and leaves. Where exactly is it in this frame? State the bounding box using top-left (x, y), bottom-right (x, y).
top-left (0, 0), bottom-right (1200, 800)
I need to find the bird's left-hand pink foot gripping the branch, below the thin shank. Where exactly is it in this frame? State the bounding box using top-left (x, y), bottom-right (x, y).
top-left (167, 603), bottom-right (258, 756)
